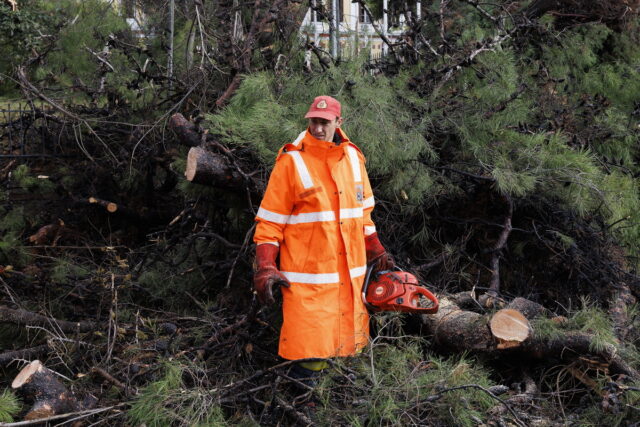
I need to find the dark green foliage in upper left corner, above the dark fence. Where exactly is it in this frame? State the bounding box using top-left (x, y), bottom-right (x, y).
top-left (0, 0), bottom-right (171, 111)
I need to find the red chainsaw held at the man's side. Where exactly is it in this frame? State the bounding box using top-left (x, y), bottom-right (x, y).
top-left (362, 267), bottom-right (438, 314)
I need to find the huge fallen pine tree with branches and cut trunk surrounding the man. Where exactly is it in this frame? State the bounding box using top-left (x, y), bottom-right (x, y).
top-left (0, 1), bottom-right (640, 425)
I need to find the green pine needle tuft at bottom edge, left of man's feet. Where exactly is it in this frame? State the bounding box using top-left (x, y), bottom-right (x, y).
top-left (127, 361), bottom-right (227, 427)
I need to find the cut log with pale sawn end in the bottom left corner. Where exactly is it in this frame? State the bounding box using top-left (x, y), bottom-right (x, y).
top-left (11, 360), bottom-right (95, 420)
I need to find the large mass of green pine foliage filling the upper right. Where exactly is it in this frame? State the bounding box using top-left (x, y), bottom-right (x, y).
top-left (420, 18), bottom-right (640, 260)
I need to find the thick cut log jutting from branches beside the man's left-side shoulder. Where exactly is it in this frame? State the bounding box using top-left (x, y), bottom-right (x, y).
top-left (184, 147), bottom-right (243, 188)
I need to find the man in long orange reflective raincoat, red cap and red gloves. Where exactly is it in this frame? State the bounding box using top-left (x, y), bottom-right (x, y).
top-left (254, 96), bottom-right (393, 378)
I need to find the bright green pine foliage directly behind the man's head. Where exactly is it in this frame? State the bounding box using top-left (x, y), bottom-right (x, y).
top-left (207, 57), bottom-right (435, 204)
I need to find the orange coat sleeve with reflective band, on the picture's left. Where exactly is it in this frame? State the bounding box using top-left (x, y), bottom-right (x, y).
top-left (253, 154), bottom-right (295, 246)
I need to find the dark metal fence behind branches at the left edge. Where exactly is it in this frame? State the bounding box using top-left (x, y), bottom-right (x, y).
top-left (0, 102), bottom-right (74, 159)
